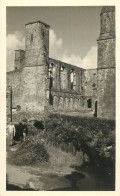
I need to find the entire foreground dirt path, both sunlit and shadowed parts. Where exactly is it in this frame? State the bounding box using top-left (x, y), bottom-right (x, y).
top-left (6, 144), bottom-right (114, 191)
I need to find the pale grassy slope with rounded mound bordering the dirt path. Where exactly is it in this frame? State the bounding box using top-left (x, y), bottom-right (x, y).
top-left (7, 125), bottom-right (83, 168)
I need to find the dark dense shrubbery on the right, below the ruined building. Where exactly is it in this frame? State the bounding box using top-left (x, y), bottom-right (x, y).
top-left (45, 116), bottom-right (115, 167)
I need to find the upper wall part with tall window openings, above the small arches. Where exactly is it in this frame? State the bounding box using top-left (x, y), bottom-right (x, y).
top-left (49, 58), bottom-right (84, 94)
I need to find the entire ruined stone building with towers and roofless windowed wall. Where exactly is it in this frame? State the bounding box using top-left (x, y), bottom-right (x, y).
top-left (7, 6), bottom-right (115, 119)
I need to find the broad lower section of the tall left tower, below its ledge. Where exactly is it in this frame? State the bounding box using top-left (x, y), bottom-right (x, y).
top-left (22, 66), bottom-right (46, 112)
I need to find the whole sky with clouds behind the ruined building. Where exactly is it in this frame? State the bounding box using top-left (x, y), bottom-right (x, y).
top-left (6, 6), bottom-right (102, 71)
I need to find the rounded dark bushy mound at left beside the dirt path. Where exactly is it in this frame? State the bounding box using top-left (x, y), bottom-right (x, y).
top-left (8, 134), bottom-right (49, 165)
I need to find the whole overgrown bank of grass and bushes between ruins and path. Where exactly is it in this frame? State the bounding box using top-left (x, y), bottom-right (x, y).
top-left (7, 115), bottom-right (115, 188)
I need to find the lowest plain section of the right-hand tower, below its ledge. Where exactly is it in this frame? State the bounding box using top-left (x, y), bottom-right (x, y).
top-left (98, 68), bottom-right (115, 119)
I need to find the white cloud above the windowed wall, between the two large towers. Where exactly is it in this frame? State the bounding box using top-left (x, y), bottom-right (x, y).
top-left (50, 29), bottom-right (97, 69)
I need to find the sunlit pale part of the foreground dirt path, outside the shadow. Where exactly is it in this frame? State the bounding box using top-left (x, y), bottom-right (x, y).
top-left (7, 164), bottom-right (75, 191)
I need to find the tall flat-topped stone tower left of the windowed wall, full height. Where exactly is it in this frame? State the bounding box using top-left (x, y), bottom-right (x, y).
top-left (22, 21), bottom-right (49, 112)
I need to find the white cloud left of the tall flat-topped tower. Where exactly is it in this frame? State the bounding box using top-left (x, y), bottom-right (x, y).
top-left (7, 31), bottom-right (25, 71)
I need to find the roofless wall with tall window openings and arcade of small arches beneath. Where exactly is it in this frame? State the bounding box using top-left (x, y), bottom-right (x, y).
top-left (49, 58), bottom-right (84, 111)
